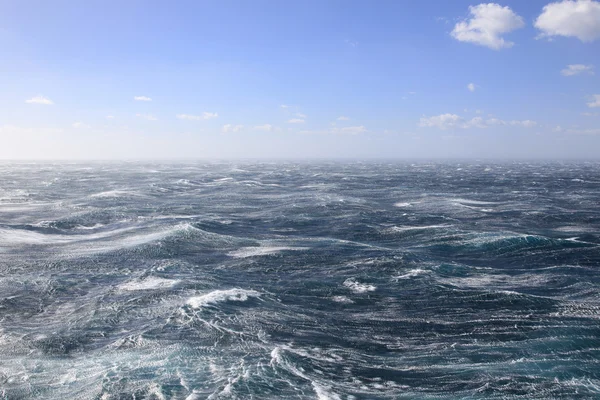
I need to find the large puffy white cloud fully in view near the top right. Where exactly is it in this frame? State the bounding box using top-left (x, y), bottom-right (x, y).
top-left (450, 3), bottom-right (525, 50)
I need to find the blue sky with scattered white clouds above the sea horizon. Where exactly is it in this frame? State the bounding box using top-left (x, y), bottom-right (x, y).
top-left (0, 0), bottom-right (600, 160)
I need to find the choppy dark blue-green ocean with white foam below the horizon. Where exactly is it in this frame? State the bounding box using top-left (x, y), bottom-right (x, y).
top-left (0, 163), bottom-right (600, 400)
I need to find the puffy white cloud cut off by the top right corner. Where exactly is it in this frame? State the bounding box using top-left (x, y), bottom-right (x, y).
top-left (534, 0), bottom-right (600, 42)
